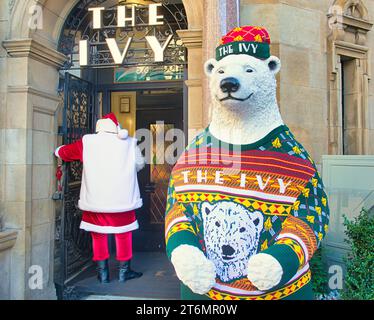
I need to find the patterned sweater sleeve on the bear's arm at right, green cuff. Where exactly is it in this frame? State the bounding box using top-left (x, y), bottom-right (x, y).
top-left (262, 171), bottom-right (329, 285)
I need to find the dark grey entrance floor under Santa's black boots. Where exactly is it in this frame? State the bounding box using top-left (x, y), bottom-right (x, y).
top-left (70, 252), bottom-right (179, 300)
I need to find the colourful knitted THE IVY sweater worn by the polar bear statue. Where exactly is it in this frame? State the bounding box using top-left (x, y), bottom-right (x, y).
top-left (165, 126), bottom-right (329, 300)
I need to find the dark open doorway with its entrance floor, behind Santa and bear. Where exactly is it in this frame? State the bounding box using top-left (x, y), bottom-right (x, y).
top-left (64, 87), bottom-right (185, 299)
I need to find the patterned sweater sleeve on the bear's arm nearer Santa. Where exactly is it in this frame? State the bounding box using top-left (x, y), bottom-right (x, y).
top-left (165, 175), bottom-right (201, 259)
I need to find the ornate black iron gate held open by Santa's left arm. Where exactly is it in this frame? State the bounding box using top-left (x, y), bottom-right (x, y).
top-left (55, 72), bottom-right (97, 299)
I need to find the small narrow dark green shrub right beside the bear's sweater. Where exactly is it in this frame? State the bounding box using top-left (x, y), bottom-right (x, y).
top-left (310, 248), bottom-right (328, 297)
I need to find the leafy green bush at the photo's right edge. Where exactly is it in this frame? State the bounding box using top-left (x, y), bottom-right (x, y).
top-left (342, 210), bottom-right (374, 300)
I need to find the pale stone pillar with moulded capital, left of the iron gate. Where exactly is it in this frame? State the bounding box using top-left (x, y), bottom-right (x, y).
top-left (3, 39), bottom-right (66, 299)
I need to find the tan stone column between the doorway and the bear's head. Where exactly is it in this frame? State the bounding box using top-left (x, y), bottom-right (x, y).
top-left (178, 0), bottom-right (239, 140)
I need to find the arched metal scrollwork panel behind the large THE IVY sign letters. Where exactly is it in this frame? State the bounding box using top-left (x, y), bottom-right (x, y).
top-left (59, 0), bottom-right (188, 69)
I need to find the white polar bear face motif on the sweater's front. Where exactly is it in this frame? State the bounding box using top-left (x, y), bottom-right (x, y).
top-left (201, 201), bottom-right (264, 282)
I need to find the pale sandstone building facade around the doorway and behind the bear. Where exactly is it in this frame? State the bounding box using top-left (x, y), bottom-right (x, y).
top-left (0, 0), bottom-right (374, 299)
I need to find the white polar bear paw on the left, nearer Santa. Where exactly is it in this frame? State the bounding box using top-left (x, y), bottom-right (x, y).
top-left (171, 245), bottom-right (216, 295)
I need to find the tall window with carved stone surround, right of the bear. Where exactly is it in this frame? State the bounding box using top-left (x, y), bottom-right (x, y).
top-left (328, 0), bottom-right (373, 155)
